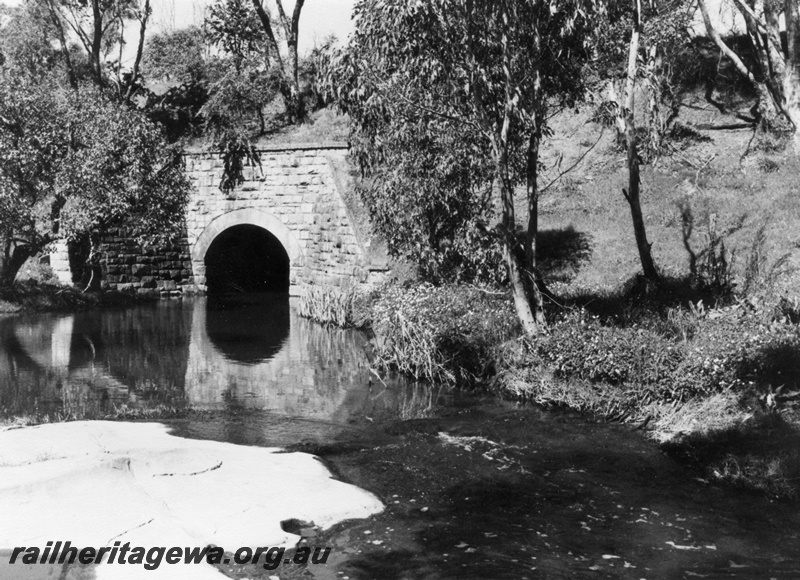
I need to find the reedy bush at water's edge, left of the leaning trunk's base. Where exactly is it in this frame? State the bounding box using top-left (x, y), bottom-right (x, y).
top-left (371, 284), bottom-right (519, 386)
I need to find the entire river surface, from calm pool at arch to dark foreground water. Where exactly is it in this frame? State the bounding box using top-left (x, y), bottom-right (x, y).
top-left (0, 297), bottom-right (800, 579)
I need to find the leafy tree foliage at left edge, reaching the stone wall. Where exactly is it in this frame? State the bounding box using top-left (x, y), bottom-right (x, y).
top-left (0, 72), bottom-right (189, 284)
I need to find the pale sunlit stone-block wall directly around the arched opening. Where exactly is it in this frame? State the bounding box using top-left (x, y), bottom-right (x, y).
top-left (186, 145), bottom-right (368, 294)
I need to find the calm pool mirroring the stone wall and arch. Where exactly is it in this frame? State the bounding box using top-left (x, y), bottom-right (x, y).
top-left (0, 296), bottom-right (444, 425)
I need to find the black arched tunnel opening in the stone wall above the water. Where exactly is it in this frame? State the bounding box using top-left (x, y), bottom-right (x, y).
top-left (205, 224), bottom-right (289, 294)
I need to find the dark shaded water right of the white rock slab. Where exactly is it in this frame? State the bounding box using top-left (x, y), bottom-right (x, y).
top-left (308, 405), bottom-right (800, 580)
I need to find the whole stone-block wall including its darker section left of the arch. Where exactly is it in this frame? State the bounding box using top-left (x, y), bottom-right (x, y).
top-left (61, 143), bottom-right (374, 294)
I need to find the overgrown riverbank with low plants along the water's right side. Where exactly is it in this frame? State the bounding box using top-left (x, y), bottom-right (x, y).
top-left (300, 279), bottom-right (800, 499)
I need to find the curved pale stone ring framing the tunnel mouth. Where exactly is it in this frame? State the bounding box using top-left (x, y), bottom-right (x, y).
top-left (191, 208), bottom-right (303, 295)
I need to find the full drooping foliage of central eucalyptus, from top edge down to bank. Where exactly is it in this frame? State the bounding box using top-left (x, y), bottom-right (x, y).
top-left (328, 0), bottom-right (598, 318)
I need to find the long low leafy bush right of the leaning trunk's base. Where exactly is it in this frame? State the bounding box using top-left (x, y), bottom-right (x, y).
top-left (501, 301), bottom-right (800, 406)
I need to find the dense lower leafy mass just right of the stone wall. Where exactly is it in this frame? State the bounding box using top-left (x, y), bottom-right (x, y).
top-left (357, 122), bottom-right (505, 282)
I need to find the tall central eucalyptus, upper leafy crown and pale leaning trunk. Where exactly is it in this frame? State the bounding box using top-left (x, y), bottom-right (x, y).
top-left (331, 0), bottom-right (602, 335)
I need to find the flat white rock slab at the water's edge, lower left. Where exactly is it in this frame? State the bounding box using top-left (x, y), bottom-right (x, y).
top-left (0, 421), bottom-right (383, 580)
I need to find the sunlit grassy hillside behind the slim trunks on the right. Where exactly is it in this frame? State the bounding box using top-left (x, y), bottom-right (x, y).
top-left (532, 93), bottom-right (800, 300)
